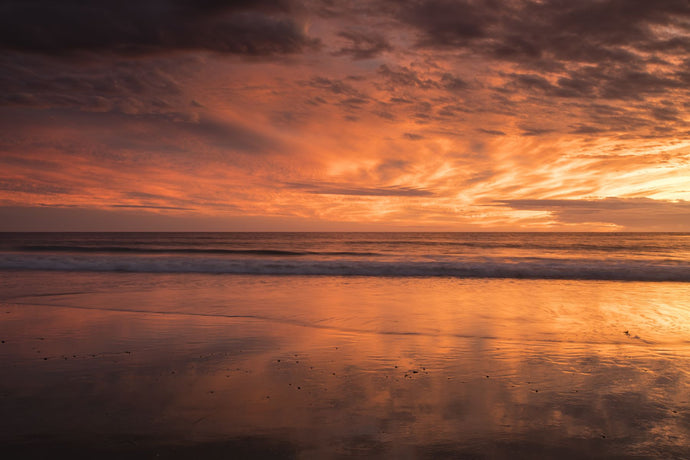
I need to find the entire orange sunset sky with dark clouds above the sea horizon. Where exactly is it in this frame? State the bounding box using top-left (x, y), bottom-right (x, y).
top-left (0, 0), bottom-right (690, 231)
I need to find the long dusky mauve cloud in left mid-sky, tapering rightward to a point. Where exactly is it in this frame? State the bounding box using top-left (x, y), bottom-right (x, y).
top-left (0, 109), bottom-right (284, 158)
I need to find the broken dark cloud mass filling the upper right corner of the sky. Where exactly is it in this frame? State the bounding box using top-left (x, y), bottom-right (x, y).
top-left (388, 0), bottom-right (690, 122)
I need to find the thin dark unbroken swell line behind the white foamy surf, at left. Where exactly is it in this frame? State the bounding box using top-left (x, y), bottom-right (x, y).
top-left (18, 245), bottom-right (380, 257)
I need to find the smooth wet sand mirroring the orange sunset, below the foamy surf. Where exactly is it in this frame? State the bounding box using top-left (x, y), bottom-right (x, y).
top-left (0, 275), bottom-right (690, 458)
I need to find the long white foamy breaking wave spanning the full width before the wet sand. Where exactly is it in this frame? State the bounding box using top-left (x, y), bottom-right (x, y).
top-left (0, 253), bottom-right (690, 282)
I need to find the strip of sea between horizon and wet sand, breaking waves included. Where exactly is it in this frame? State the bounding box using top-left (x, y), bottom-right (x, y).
top-left (0, 233), bottom-right (690, 282)
